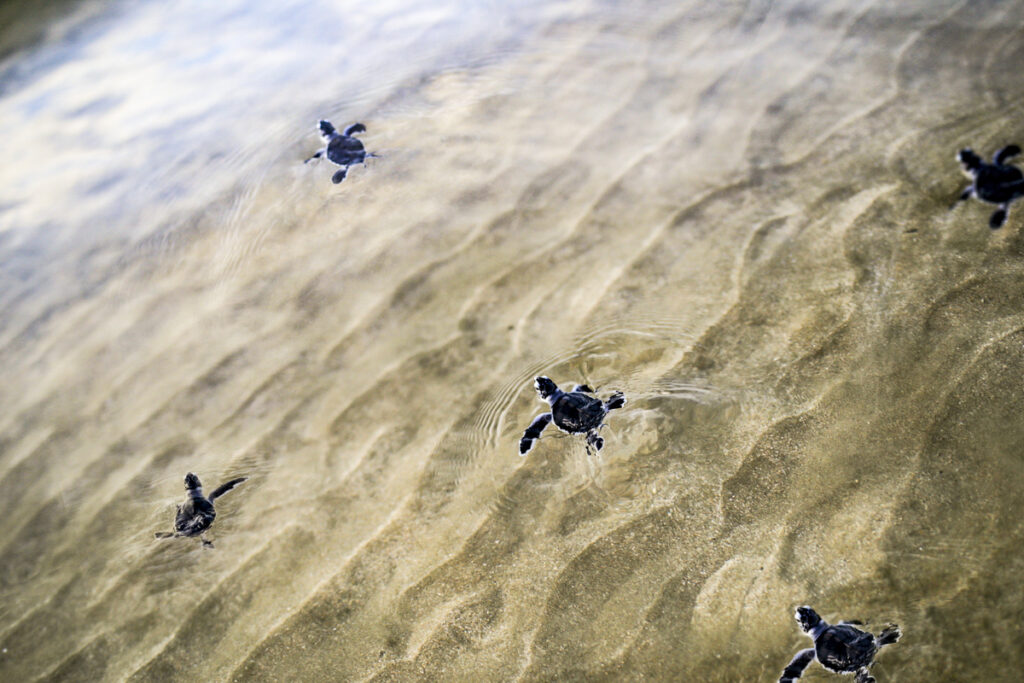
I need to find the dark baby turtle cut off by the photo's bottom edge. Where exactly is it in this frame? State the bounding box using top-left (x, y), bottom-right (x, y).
top-left (778, 606), bottom-right (902, 683)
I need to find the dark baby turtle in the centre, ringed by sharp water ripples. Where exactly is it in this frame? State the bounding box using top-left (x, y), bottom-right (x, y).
top-left (519, 377), bottom-right (626, 456)
